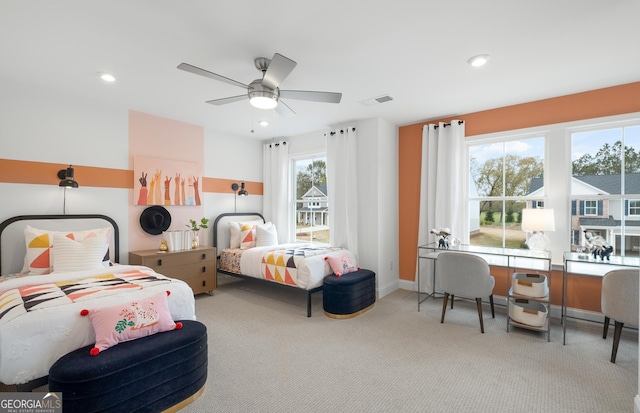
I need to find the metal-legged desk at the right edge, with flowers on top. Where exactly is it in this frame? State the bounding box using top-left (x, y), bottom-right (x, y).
top-left (561, 252), bottom-right (640, 344)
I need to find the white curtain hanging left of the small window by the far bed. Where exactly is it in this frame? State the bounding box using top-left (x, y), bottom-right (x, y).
top-left (262, 141), bottom-right (291, 243)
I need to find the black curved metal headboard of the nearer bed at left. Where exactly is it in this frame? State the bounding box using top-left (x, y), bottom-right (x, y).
top-left (0, 214), bottom-right (120, 275)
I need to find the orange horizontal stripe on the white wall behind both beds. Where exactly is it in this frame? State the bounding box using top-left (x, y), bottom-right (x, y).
top-left (0, 159), bottom-right (263, 195)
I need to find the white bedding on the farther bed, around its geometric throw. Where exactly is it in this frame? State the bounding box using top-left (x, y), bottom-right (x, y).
top-left (240, 243), bottom-right (353, 290)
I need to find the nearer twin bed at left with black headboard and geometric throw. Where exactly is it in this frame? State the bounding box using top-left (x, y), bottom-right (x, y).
top-left (0, 215), bottom-right (196, 391)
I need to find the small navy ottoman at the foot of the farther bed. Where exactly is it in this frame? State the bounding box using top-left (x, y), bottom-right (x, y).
top-left (322, 269), bottom-right (376, 318)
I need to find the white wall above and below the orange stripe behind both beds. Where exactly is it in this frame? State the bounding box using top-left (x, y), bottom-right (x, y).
top-left (0, 80), bottom-right (262, 263)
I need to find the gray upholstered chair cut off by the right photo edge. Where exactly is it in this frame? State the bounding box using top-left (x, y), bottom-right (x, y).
top-left (601, 269), bottom-right (640, 363)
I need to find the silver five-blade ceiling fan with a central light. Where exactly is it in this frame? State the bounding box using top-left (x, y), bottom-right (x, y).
top-left (178, 53), bottom-right (342, 117)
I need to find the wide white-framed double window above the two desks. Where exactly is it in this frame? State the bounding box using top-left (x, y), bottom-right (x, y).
top-left (467, 114), bottom-right (640, 262)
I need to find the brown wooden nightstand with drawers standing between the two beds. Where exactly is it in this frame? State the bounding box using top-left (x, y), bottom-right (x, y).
top-left (129, 247), bottom-right (216, 295)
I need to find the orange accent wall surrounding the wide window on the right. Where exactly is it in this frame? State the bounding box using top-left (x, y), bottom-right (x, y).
top-left (398, 82), bottom-right (640, 284)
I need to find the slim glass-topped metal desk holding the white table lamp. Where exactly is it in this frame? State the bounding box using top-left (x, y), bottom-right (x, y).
top-left (418, 242), bottom-right (551, 341)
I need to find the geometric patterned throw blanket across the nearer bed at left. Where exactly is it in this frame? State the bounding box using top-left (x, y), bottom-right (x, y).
top-left (0, 270), bottom-right (171, 325)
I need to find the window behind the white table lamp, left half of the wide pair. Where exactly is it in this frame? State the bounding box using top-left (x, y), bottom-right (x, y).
top-left (468, 136), bottom-right (545, 248)
